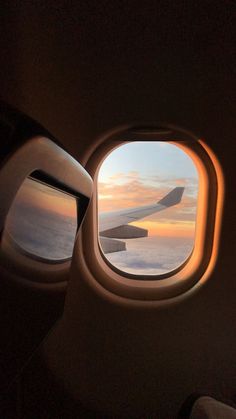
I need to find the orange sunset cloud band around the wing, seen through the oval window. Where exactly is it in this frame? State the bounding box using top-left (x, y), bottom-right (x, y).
top-left (98, 178), bottom-right (196, 238)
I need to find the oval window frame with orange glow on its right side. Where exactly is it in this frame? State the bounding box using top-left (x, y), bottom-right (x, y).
top-left (76, 127), bottom-right (224, 304)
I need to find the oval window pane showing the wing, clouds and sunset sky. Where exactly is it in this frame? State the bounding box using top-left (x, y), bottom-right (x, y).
top-left (98, 141), bottom-right (198, 279)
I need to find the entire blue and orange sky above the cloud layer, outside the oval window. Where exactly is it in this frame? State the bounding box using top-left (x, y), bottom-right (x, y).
top-left (98, 142), bottom-right (198, 238)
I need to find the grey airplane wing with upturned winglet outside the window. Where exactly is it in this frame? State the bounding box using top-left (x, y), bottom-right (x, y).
top-left (99, 187), bottom-right (184, 253)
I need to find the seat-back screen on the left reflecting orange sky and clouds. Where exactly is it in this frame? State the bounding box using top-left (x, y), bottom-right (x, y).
top-left (4, 178), bottom-right (77, 260)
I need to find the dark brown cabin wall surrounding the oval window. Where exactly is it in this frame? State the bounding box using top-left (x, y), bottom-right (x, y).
top-left (0, 2), bottom-right (236, 419)
